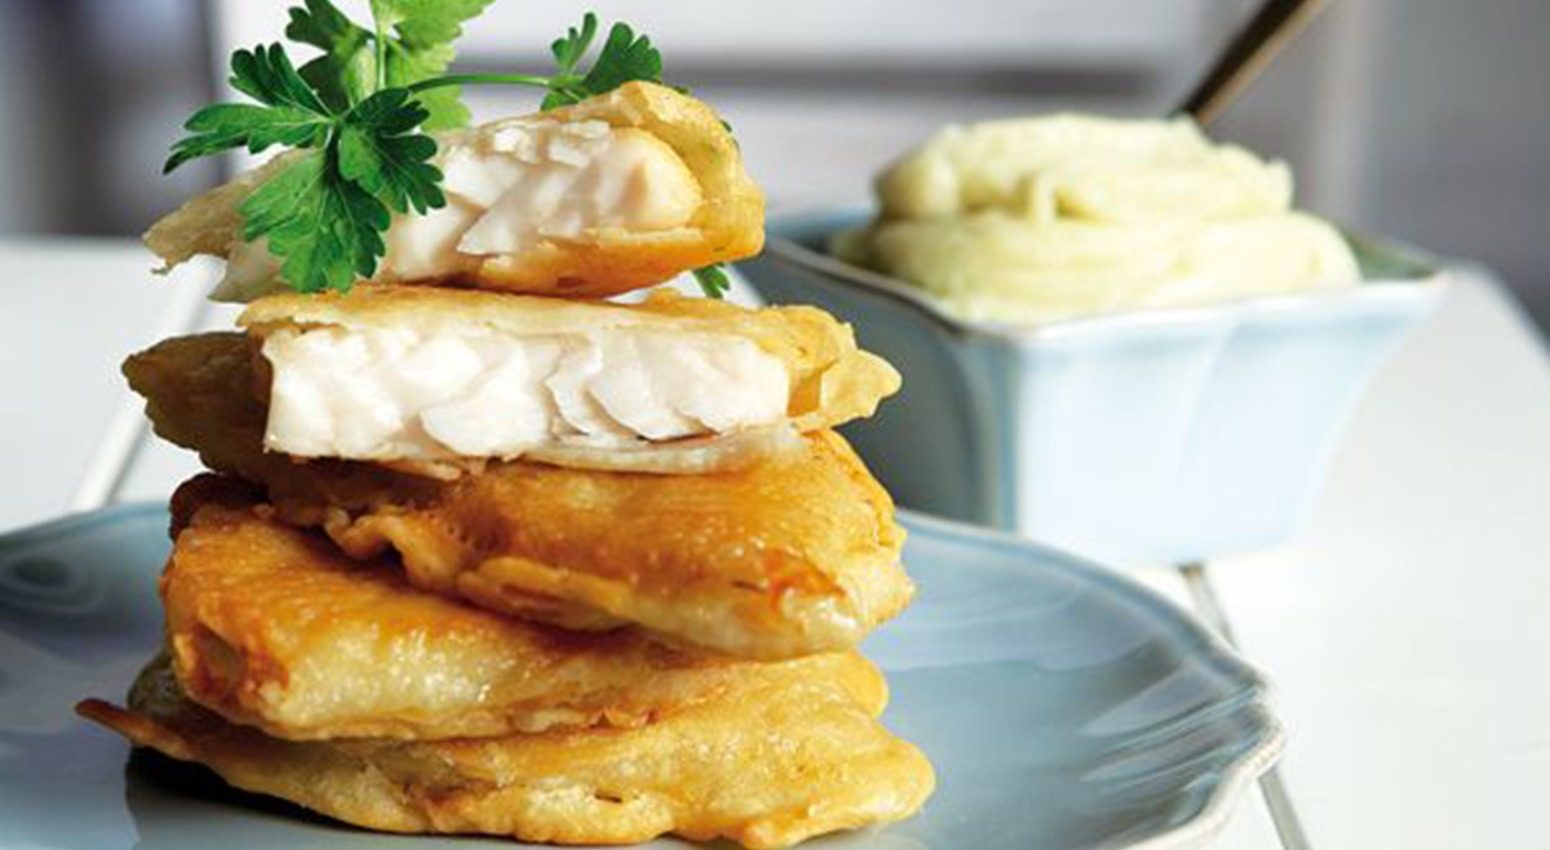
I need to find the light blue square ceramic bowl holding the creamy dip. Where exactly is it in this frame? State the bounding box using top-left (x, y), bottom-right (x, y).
top-left (739, 209), bottom-right (1442, 565)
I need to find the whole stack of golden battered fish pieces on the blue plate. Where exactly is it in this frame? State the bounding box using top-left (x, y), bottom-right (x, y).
top-left (79, 84), bottom-right (933, 848)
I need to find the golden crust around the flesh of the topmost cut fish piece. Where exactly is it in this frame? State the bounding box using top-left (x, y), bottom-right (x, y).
top-left (144, 82), bottom-right (764, 298)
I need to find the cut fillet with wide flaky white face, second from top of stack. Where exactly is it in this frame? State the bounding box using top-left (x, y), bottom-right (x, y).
top-left (239, 287), bottom-right (899, 473)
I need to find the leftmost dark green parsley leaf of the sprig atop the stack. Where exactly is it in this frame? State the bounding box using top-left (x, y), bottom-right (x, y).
top-left (161, 45), bottom-right (333, 172)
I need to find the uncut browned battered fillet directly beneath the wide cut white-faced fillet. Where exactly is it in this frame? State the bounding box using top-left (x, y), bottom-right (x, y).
top-left (133, 333), bottom-right (913, 659)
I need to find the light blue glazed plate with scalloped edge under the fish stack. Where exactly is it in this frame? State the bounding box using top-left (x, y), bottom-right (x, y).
top-left (0, 506), bottom-right (1282, 850)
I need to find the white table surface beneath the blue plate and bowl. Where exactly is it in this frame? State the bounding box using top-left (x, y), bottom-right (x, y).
top-left (0, 240), bottom-right (1550, 850)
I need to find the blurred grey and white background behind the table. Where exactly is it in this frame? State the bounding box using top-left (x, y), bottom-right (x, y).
top-left (0, 0), bottom-right (1550, 329)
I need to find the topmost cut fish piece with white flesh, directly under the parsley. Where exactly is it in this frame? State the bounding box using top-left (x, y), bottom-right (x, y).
top-left (146, 82), bottom-right (764, 301)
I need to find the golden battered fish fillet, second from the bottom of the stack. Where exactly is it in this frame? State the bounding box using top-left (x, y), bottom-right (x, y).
top-left (161, 475), bottom-right (887, 740)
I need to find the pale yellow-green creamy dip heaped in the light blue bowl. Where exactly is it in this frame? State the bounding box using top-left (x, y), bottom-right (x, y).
top-left (832, 115), bottom-right (1361, 324)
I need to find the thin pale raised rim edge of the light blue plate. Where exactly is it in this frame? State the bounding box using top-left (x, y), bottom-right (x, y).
top-left (0, 501), bottom-right (1287, 850)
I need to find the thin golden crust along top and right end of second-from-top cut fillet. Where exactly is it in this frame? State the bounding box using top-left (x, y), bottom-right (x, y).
top-left (237, 287), bottom-right (899, 443)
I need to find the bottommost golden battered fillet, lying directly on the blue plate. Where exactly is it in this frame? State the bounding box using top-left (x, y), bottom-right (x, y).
top-left (76, 661), bottom-right (935, 850)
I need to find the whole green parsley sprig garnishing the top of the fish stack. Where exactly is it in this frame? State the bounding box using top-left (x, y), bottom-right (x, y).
top-left (163, 0), bottom-right (729, 298)
